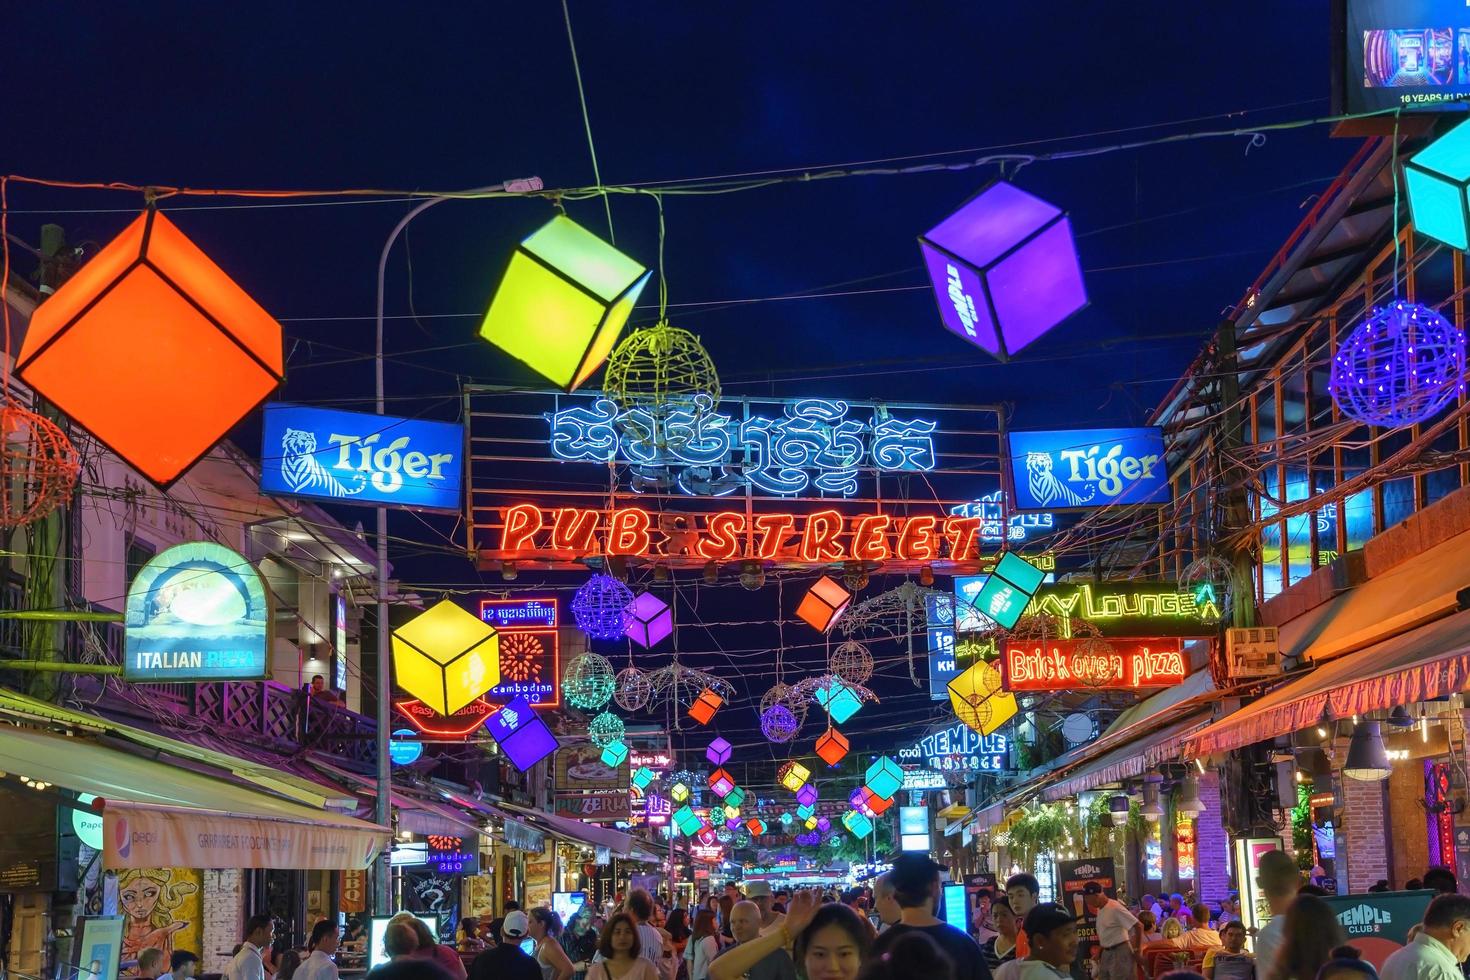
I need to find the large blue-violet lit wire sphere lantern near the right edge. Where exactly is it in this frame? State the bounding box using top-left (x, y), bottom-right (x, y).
top-left (1329, 300), bottom-right (1466, 429)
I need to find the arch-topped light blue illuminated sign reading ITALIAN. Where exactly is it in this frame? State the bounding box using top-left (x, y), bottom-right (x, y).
top-left (122, 541), bottom-right (270, 683)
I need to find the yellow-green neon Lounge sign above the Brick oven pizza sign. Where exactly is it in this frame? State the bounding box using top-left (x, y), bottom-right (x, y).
top-left (1028, 582), bottom-right (1220, 636)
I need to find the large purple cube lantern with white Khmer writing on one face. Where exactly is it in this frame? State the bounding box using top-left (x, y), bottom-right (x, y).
top-left (919, 181), bottom-right (1088, 360)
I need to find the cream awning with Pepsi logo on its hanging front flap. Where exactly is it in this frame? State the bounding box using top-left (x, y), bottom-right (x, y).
top-left (0, 726), bottom-right (388, 870)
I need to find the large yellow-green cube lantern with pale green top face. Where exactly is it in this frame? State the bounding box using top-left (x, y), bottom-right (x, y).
top-left (479, 215), bottom-right (651, 391)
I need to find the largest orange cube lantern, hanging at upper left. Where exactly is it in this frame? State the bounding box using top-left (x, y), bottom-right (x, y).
top-left (16, 209), bottom-right (284, 486)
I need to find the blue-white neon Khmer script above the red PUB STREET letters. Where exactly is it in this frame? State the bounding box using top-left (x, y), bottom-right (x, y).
top-left (547, 394), bottom-right (938, 497)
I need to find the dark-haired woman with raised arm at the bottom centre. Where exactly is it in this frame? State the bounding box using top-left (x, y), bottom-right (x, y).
top-left (710, 889), bottom-right (873, 980)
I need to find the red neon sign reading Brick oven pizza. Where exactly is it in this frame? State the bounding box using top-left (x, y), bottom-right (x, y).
top-left (1001, 639), bottom-right (1189, 691)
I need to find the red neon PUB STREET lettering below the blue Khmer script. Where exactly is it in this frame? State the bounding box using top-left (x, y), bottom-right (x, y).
top-left (498, 504), bottom-right (980, 564)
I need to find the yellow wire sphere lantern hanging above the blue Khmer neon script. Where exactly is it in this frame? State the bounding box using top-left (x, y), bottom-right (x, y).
top-left (603, 320), bottom-right (720, 414)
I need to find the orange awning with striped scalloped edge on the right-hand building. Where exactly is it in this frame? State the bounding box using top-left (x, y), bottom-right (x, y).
top-left (1185, 611), bottom-right (1470, 757)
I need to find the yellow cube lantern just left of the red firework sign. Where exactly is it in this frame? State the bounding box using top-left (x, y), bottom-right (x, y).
top-left (392, 599), bottom-right (500, 714)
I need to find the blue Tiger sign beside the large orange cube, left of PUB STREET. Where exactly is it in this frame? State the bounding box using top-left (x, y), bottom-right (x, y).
top-left (260, 403), bottom-right (465, 510)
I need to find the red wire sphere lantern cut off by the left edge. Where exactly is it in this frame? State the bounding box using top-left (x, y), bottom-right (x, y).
top-left (0, 404), bottom-right (81, 527)
